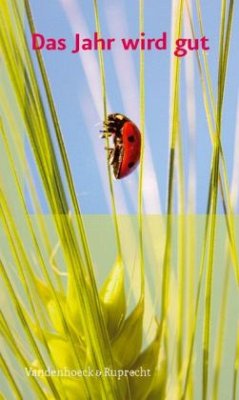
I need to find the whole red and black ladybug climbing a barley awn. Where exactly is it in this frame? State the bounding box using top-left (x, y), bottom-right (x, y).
top-left (102, 113), bottom-right (141, 179)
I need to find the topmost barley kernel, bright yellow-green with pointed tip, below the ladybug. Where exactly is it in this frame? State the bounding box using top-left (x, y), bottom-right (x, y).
top-left (100, 258), bottom-right (126, 338)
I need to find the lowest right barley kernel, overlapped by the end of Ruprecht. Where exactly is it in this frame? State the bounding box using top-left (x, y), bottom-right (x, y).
top-left (129, 327), bottom-right (162, 400)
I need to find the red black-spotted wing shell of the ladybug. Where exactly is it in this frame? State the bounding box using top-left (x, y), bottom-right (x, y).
top-left (116, 121), bottom-right (141, 179)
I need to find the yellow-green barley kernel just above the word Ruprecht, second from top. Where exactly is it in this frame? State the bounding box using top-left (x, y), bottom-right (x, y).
top-left (112, 298), bottom-right (144, 368)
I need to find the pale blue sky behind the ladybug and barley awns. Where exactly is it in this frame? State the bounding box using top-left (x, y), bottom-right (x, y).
top-left (29, 0), bottom-right (239, 214)
